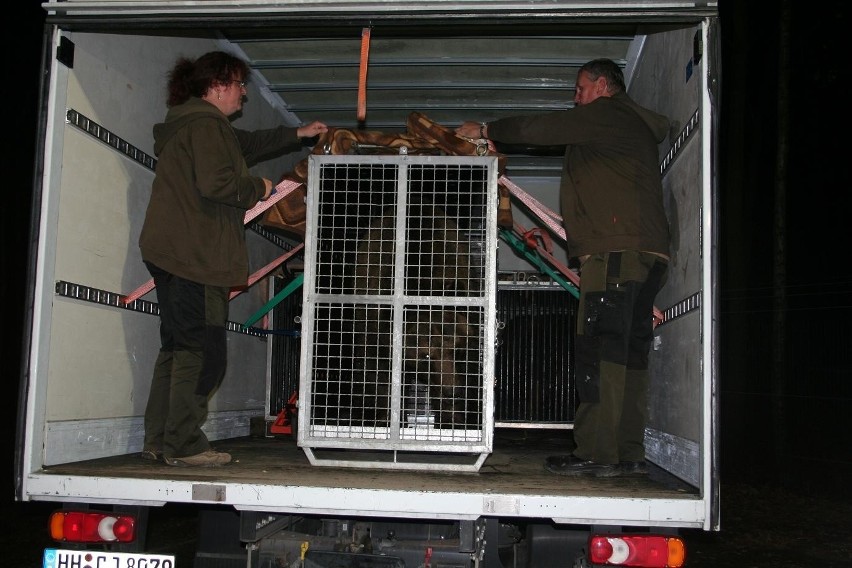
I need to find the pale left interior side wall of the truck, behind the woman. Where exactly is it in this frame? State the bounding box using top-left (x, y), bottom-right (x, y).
top-left (36, 32), bottom-right (302, 465)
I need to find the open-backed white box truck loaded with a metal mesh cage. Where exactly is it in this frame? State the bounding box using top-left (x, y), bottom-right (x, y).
top-left (16, 0), bottom-right (719, 568)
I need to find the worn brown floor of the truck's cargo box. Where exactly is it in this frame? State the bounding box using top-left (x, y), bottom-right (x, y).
top-left (42, 428), bottom-right (697, 499)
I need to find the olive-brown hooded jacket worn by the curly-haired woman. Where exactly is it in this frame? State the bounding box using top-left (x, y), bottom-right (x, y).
top-left (144, 98), bottom-right (300, 287)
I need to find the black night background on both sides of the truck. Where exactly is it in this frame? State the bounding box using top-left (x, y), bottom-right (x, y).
top-left (0, 0), bottom-right (852, 566)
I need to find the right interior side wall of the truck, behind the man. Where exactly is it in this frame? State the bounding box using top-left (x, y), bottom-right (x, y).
top-left (630, 27), bottom-right (710, 486)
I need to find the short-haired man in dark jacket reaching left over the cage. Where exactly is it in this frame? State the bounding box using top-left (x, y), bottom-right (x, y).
top-left (456, 59), bottom-right (669, 477)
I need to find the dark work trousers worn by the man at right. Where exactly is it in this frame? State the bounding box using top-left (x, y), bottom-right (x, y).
top-left (574, 251), bottom-right (668, 464)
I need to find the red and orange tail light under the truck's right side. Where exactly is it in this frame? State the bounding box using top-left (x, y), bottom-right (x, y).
top-left (589, 534), bottom-right (686, 568)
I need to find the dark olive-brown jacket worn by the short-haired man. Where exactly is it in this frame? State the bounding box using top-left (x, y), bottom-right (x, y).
top-left (488, 93), bottom-right (669, 257)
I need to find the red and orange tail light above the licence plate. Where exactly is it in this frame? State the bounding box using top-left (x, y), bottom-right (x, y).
top-left (50, 511), bottom-right (136, 542)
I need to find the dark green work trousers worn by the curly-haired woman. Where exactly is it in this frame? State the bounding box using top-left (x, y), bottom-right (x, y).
top-left (144, 262), bottom-right (230, 458)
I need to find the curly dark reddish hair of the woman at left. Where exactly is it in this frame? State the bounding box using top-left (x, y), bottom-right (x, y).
top-left (166, 51), bottom-right (249, 107)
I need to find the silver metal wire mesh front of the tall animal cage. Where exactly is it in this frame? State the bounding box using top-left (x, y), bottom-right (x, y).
top-left (298, 155), bottom-right (497, 470)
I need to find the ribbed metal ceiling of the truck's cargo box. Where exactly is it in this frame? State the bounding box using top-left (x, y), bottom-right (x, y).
top-left (44, 0), bottom-right (715, 169)
